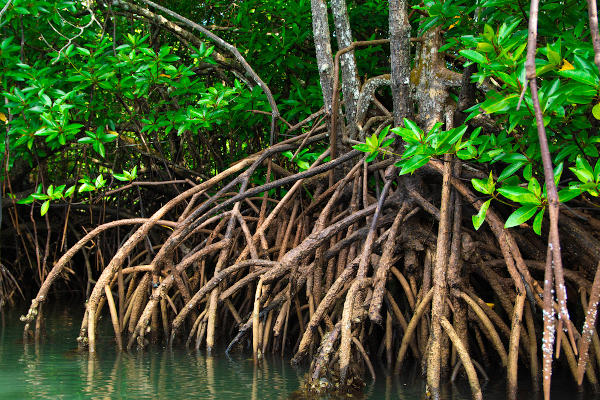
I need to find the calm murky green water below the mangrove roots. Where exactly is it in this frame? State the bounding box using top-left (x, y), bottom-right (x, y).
top-left (0, 308), bottom-right (594, 400)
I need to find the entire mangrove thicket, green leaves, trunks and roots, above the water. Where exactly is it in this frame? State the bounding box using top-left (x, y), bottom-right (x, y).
top-left (0, 0), bottom-right (600, 398)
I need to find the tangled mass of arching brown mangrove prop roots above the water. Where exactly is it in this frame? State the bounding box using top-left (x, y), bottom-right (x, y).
top-left (23, 135), bottom-right (600, 398)
